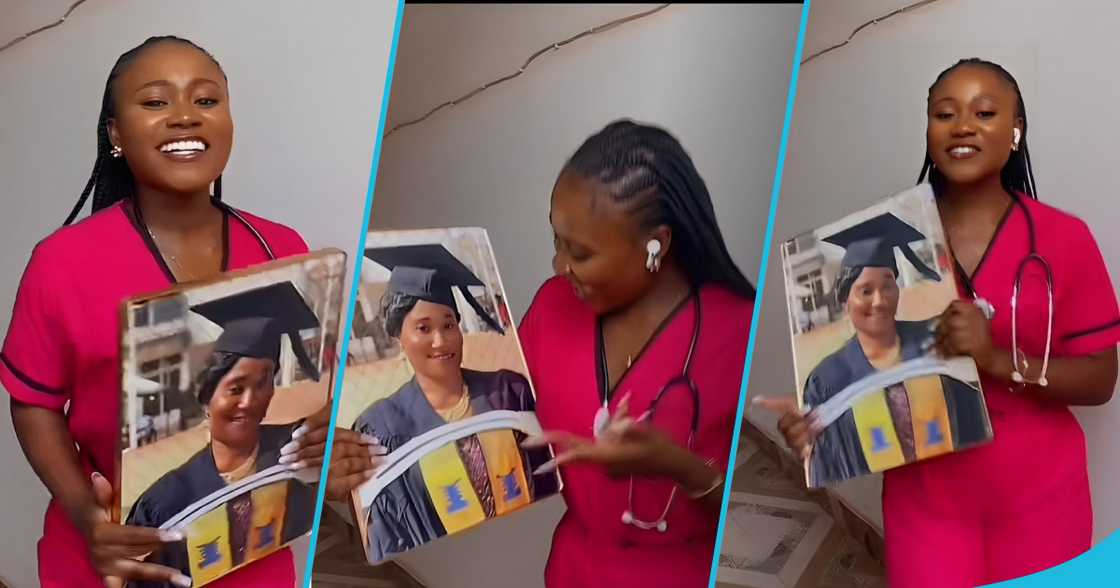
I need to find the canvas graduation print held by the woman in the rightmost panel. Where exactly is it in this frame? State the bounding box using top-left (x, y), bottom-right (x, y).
top-left (782, 185), bottom-right (992, 487)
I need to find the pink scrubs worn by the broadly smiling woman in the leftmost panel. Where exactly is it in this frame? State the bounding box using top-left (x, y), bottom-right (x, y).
top-left (0, 200), bottom-right (308, 588)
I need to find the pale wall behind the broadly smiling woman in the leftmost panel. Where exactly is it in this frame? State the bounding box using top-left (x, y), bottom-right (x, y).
top-left (0, 0), bottom-right (398, 587)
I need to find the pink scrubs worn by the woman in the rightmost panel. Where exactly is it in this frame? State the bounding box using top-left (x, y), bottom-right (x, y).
top-left (883, 195), bottom-right (1120, 587)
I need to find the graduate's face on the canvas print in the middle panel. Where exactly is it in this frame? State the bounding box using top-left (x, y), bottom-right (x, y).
top-left (398, 300), bottom-right (463, 380)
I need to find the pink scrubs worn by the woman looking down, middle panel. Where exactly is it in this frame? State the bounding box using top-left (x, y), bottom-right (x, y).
top-left (520, 277), bottom-right (754, 588)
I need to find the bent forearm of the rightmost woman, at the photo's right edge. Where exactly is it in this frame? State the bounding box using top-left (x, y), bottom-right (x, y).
top-left (978, 348), bottom-right (1117, 405)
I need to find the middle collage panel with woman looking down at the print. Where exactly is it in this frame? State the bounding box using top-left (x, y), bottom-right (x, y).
top-left (311, 3), bottom-right (801, 588)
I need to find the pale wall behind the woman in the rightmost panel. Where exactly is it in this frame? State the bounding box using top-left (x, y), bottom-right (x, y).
top-left (749, 0), bottom-right (1120, 540)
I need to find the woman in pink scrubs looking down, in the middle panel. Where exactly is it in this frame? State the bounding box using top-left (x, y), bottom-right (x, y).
top-left (520, 121), bottom-right (755, 588)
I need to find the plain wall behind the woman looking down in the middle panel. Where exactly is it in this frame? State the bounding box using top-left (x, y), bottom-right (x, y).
top-left (362, 4), bottom-right (801, 588)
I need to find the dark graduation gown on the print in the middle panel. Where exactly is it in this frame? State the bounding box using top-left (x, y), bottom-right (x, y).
top-left (352, 370), bottom-right (558, 561)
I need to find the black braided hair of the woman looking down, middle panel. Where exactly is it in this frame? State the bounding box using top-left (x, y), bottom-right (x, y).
top-left (563, 120), bottom-right (755, 300)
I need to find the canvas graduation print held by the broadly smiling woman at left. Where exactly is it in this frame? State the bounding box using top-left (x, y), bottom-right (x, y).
top-left (120, 250), bottom-right (346, 586)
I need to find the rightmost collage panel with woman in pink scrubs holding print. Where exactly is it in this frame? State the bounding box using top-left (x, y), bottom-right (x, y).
top-left (730, 1), bottom-right (1120, 588)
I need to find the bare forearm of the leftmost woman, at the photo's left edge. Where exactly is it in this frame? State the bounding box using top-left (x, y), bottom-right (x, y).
top-left (11, 399), bottom-right (96, 522)
